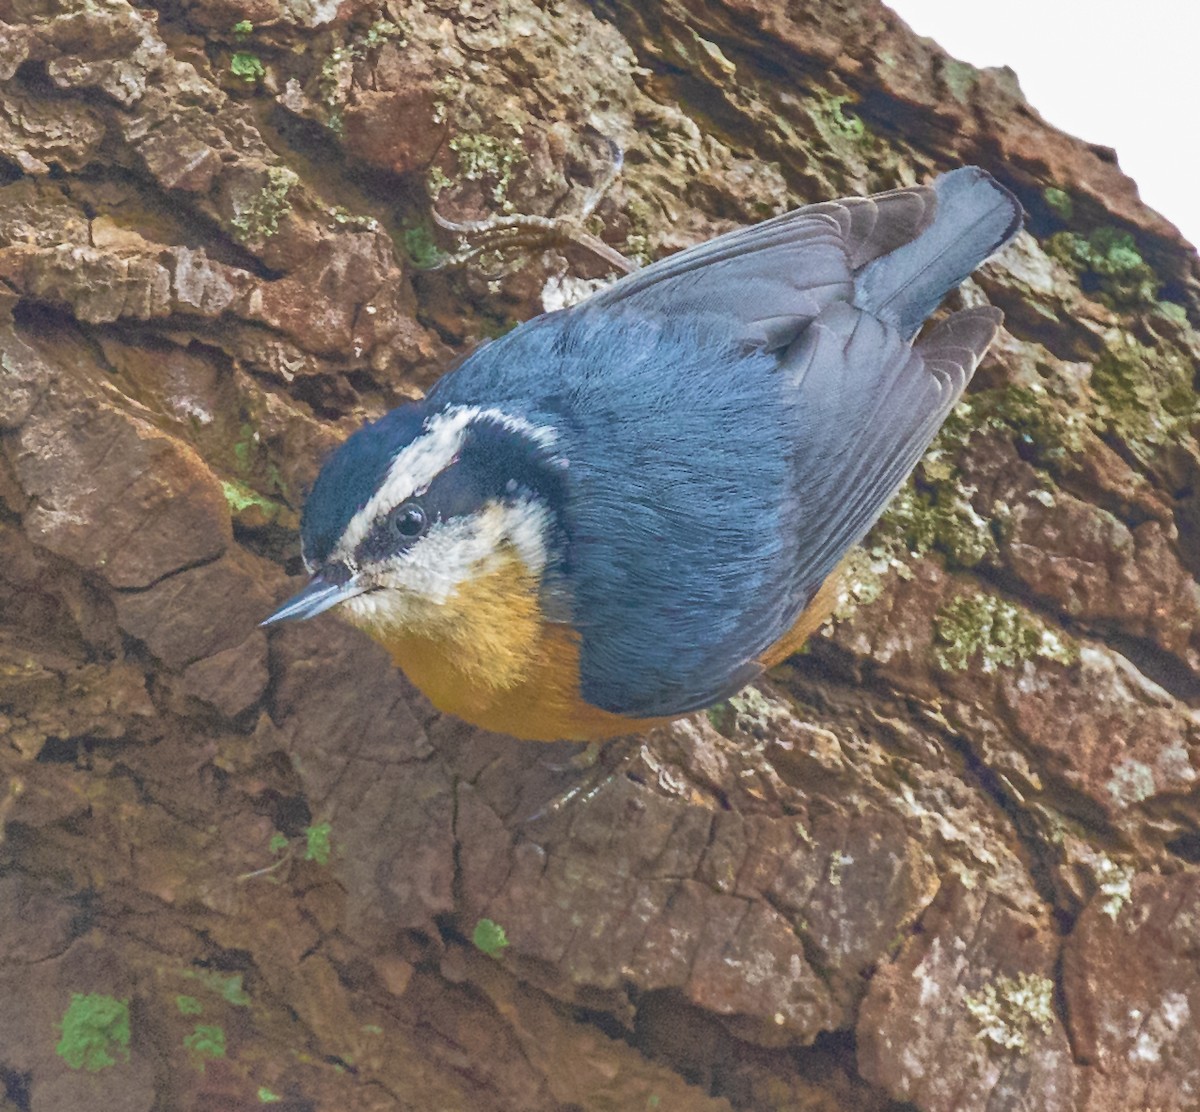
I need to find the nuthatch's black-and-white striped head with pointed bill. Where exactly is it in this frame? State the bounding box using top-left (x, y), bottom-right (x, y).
top-left (263, 403), bottom-right (566, 643)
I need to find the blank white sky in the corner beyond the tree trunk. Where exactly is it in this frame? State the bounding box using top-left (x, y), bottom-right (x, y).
top-left (884, 0), bottom-right (1200, 245)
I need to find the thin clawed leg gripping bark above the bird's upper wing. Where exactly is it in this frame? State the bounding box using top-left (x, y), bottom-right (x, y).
top-left (431, 139), bottom-right (637, 274)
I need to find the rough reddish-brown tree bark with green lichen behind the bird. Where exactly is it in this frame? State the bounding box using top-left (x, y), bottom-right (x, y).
top-left (0, 0), bottom-right (1200, 1112)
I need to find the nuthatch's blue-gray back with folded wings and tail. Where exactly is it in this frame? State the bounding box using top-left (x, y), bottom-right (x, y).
top-left (431, 168), bottom-right (1020, 717)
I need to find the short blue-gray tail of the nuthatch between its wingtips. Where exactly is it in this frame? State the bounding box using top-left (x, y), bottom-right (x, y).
top-left (854, 166), bottom-right (1022, 337)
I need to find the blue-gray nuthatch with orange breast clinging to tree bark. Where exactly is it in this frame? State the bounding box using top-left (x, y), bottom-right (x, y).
top-left (263, 167), bottom-right (1022, 743)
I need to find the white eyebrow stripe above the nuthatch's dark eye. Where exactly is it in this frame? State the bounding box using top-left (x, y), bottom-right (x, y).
top-left (334, 405), bottom-right (557, 567)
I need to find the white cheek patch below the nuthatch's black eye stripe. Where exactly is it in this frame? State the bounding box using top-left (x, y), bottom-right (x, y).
top-left (343, 500), bottom-right (550, 626)
